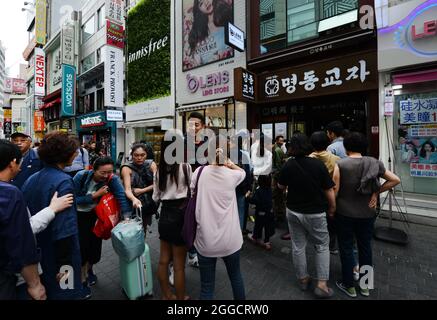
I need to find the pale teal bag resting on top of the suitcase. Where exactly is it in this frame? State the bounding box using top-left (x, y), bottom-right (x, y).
top-left (111, 208), bottom-right (145, 262)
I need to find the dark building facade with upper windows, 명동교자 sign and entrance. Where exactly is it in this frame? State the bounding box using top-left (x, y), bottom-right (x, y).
top-left (247, 0), bottom-right (379, 157)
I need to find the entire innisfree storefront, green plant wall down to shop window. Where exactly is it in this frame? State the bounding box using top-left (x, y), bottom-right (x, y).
top-left (124, 0), bottom-right (175, 161)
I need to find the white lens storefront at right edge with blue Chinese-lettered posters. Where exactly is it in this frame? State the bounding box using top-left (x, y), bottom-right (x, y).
top-left (378, 0), bottom-right (437, 217)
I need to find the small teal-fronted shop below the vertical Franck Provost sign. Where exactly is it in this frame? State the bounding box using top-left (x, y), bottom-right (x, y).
top-left (76, 112), bottom-right (117, 161)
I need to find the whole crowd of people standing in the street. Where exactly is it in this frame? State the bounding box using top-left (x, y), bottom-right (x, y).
top-left (0, 116), bottom-right (400, 300)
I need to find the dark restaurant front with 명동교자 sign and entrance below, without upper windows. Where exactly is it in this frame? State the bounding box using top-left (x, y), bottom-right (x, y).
top-left (248, 50), bottom-right (379, 156)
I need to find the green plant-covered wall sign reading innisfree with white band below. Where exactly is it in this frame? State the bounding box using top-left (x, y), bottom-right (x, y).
top-left (126, 0), bottom-right (173, 121)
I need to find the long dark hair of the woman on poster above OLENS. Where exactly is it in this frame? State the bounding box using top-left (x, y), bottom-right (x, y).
top-left (188, 0), bottom-right (232, 54)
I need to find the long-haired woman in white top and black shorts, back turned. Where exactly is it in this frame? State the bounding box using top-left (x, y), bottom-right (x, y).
top-left (153, 140), bottom-right (192, 300)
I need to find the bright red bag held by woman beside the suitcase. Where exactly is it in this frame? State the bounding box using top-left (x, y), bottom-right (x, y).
top-left (93, 175), bottom-right (121, 240)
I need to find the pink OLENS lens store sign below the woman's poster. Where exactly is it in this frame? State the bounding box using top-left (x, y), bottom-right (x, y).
top-left (187, 71), bottom-right (230, 97)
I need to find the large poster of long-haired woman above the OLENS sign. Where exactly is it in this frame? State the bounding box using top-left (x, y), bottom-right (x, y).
top-left (182, 0), bottom-right (234, 71)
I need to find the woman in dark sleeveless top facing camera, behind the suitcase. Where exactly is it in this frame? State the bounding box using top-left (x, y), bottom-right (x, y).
top-left (121, 143), bottom-right (157, 234)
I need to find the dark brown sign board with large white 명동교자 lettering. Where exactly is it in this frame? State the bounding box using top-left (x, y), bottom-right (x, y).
top-left (258, 53), bottom-right (378, 102)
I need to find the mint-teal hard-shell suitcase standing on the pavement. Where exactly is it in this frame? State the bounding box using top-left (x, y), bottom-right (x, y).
top-left (120, 244), bottom-right (153, 300)
